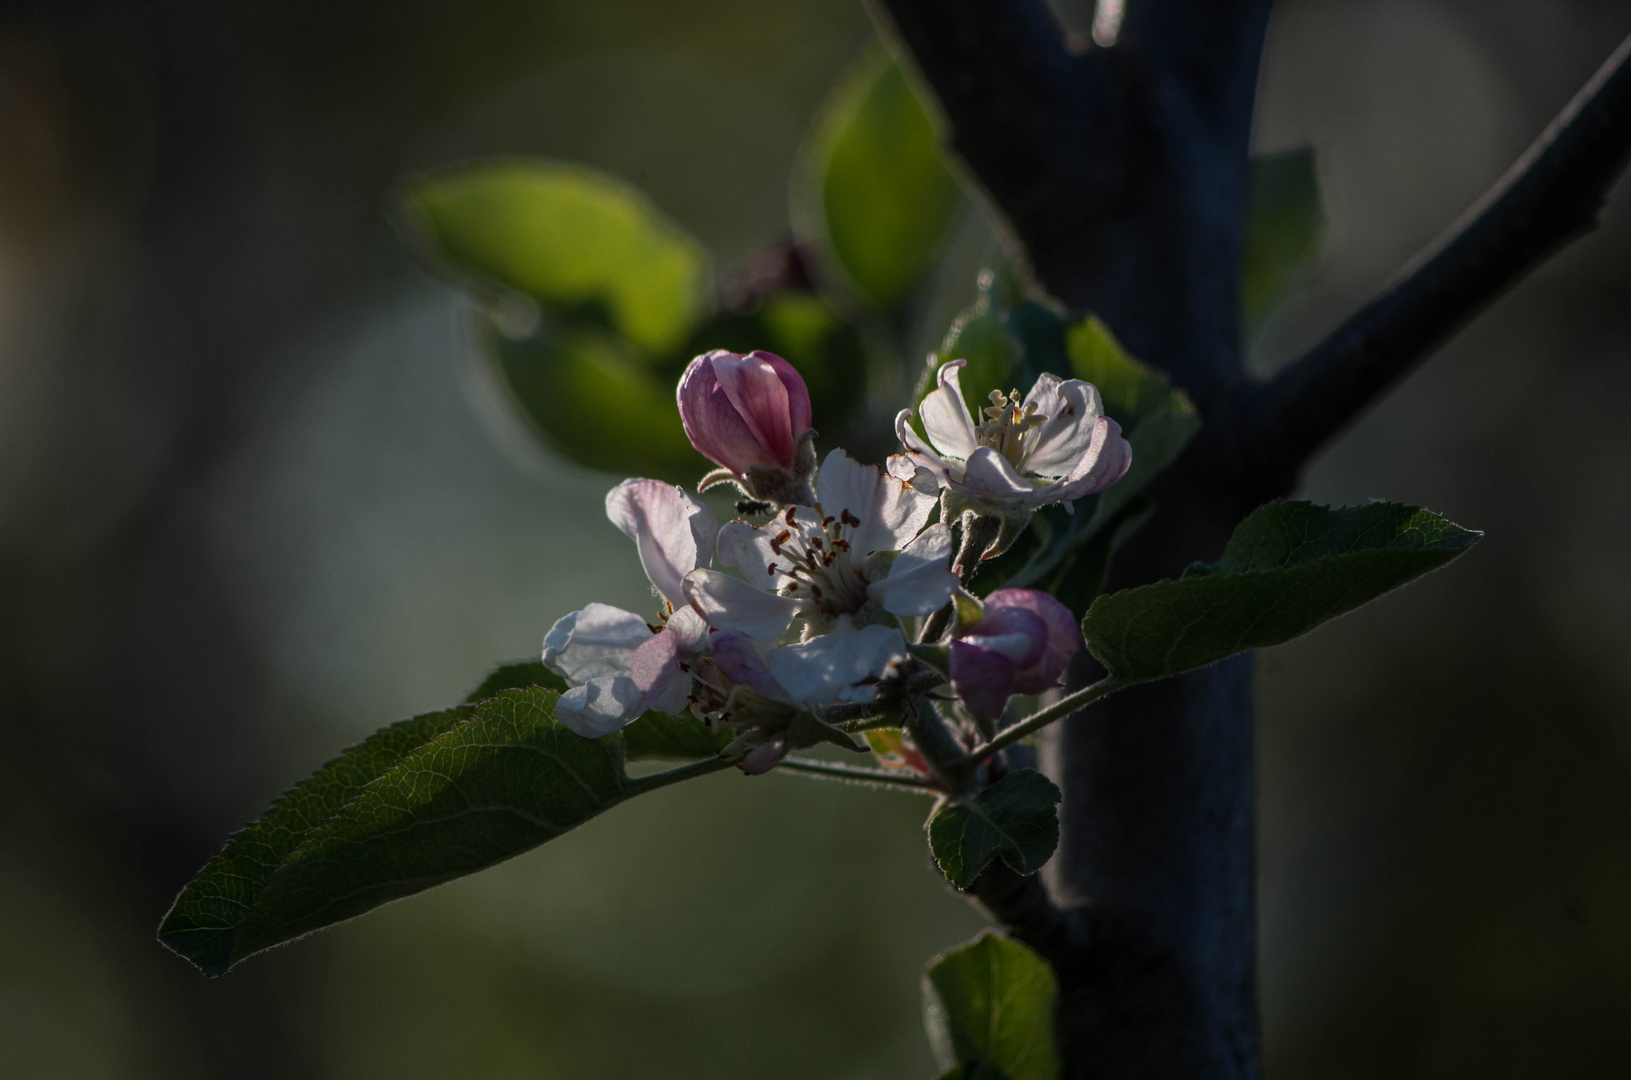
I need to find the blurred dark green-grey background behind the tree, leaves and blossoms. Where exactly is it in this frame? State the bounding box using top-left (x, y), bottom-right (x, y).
top-left (0, 0), bottom-right (1631, 1080)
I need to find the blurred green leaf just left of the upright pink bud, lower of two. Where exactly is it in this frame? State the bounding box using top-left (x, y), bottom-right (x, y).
top-left (488, 314), bottom-right (708, 483)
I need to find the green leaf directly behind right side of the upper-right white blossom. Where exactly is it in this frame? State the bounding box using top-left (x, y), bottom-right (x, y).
top-left (1065, 315), bottom-right (1200, 535)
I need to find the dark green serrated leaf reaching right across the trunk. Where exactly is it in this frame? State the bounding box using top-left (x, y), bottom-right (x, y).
top-left (1081, 501), bottom-right (1481, 682)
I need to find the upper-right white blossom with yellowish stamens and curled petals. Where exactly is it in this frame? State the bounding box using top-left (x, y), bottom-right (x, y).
top-left (891, 361), bottom-right (1132, 512)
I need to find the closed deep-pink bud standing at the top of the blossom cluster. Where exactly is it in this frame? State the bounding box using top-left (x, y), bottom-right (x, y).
top-left (675, 349), bottom-right (811, 478)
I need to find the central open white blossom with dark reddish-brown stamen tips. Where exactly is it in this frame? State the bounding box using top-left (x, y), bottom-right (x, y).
top-left (685, 450), bottom-right (957, 648)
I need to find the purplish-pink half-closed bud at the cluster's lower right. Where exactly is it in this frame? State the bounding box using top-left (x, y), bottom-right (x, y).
top-left (951, 589), bottom-right (1081, 719)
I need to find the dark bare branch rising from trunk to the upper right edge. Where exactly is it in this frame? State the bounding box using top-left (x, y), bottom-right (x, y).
top-left (1233, 38), bottom-right (1631, 489)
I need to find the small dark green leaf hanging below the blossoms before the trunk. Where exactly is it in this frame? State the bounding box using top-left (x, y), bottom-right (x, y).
top-left (928, 768), bottom-right (1062, 889)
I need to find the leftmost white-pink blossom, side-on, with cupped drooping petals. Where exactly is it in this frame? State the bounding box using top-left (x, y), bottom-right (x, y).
top-left (543, 480), bottom-right (719, 739)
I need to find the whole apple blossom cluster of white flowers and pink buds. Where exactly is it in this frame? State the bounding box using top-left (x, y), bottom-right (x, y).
top-left (543, 351), bottom-right (1130, 773)
